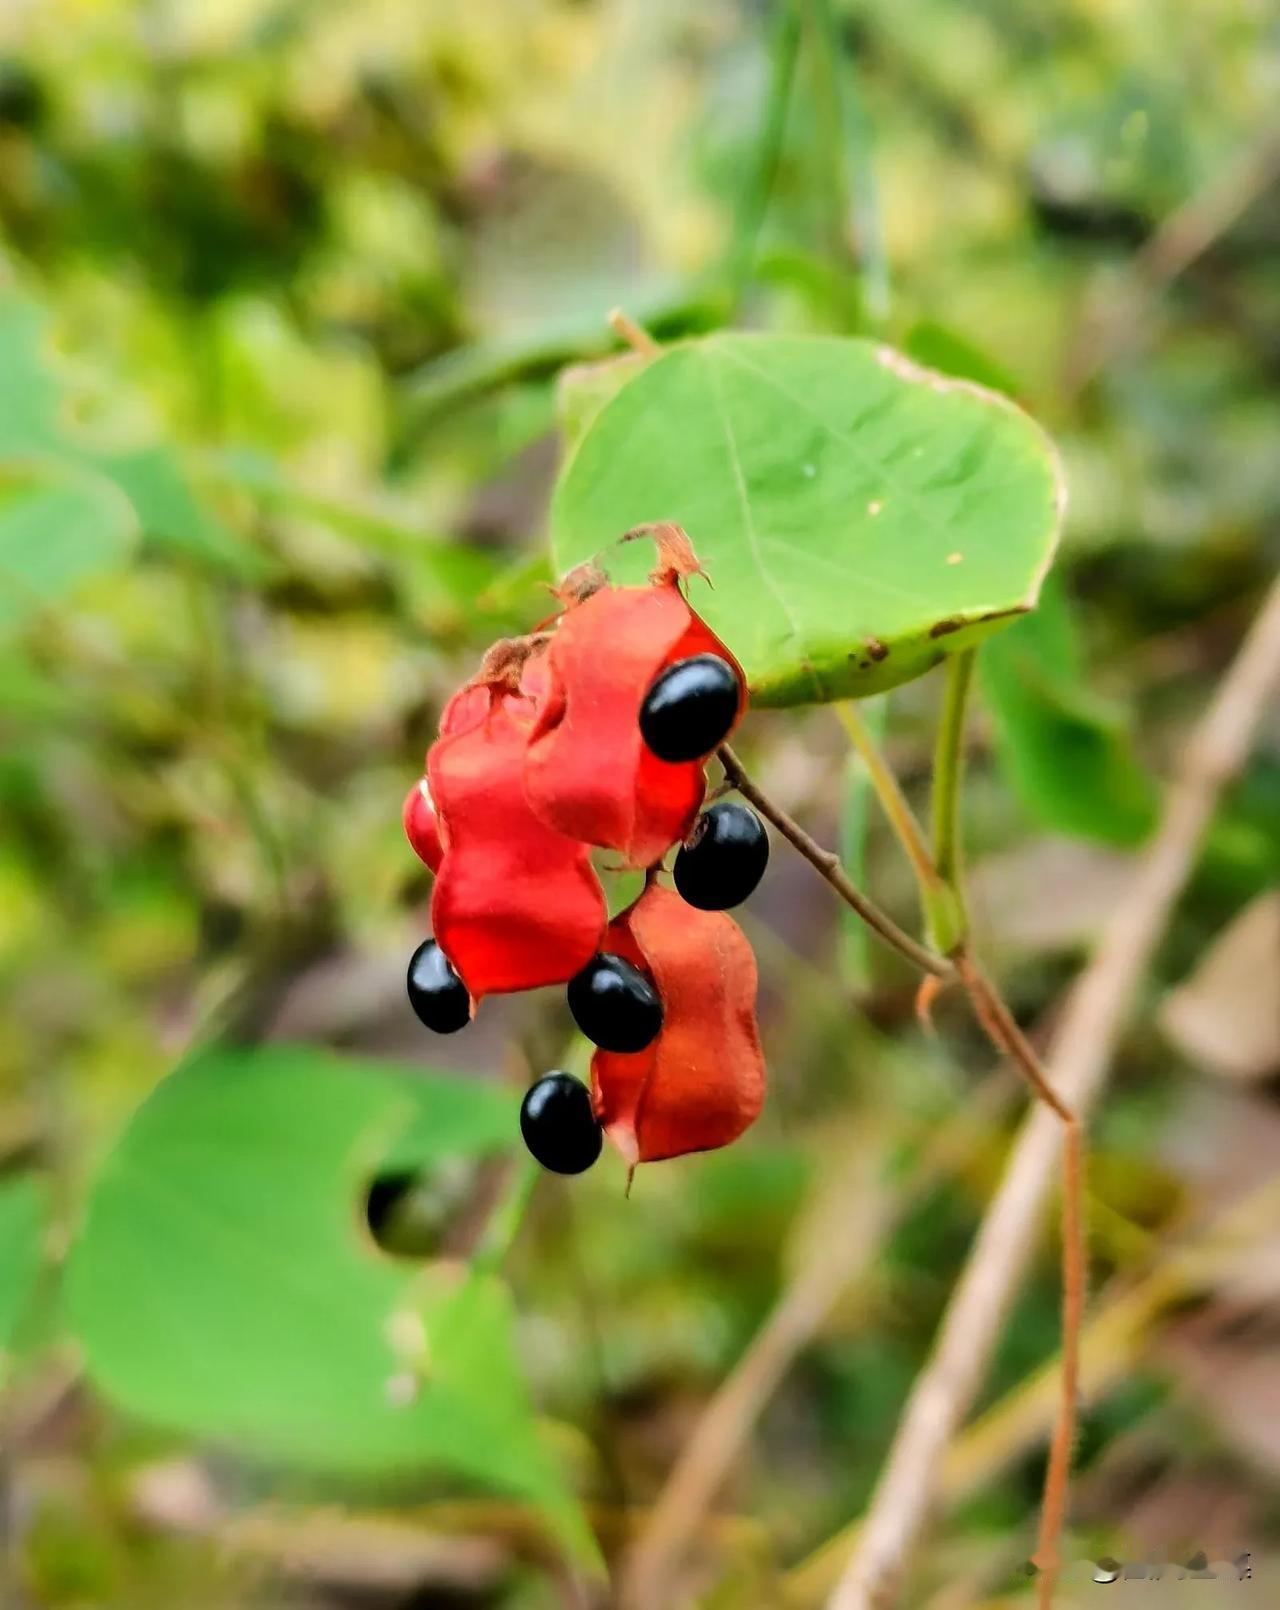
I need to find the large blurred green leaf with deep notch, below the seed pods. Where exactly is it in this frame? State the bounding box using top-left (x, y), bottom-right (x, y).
top-left (66, 1047), bottom-right (594, 1557)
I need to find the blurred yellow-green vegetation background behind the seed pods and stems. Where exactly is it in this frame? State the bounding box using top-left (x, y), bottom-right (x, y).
top-left (0, 0), bottom-right (1280, 1610)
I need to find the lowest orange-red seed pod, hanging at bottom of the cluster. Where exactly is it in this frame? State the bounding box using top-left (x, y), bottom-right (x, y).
top-left (591, 884), bottom-right (765, 1164)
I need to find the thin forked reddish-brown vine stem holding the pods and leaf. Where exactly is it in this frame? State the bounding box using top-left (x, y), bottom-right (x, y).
top-left (718, 650), bottom-right (1087, 1610)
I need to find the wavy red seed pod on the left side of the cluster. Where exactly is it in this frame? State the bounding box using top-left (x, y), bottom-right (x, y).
top-left (427, 686), bottom-right (607, 1001)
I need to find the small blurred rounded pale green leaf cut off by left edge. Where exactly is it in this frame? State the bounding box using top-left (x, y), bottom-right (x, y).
top-left (0, 477), bottom-right (137, 636)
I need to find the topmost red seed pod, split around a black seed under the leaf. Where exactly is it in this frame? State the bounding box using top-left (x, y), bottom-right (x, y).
top-left (525, 573), bottom-right (747, 866)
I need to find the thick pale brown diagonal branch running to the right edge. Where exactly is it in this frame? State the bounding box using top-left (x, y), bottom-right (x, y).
top-left (829, 581), bottom-right (1280, 1610)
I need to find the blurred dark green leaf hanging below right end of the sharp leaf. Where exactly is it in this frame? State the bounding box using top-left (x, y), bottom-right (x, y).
top-left (979, 586), bottom-right (1158, 845)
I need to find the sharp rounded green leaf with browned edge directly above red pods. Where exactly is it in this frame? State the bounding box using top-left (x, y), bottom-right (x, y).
top-left (552, 335), bottom-right (1063, 705)
